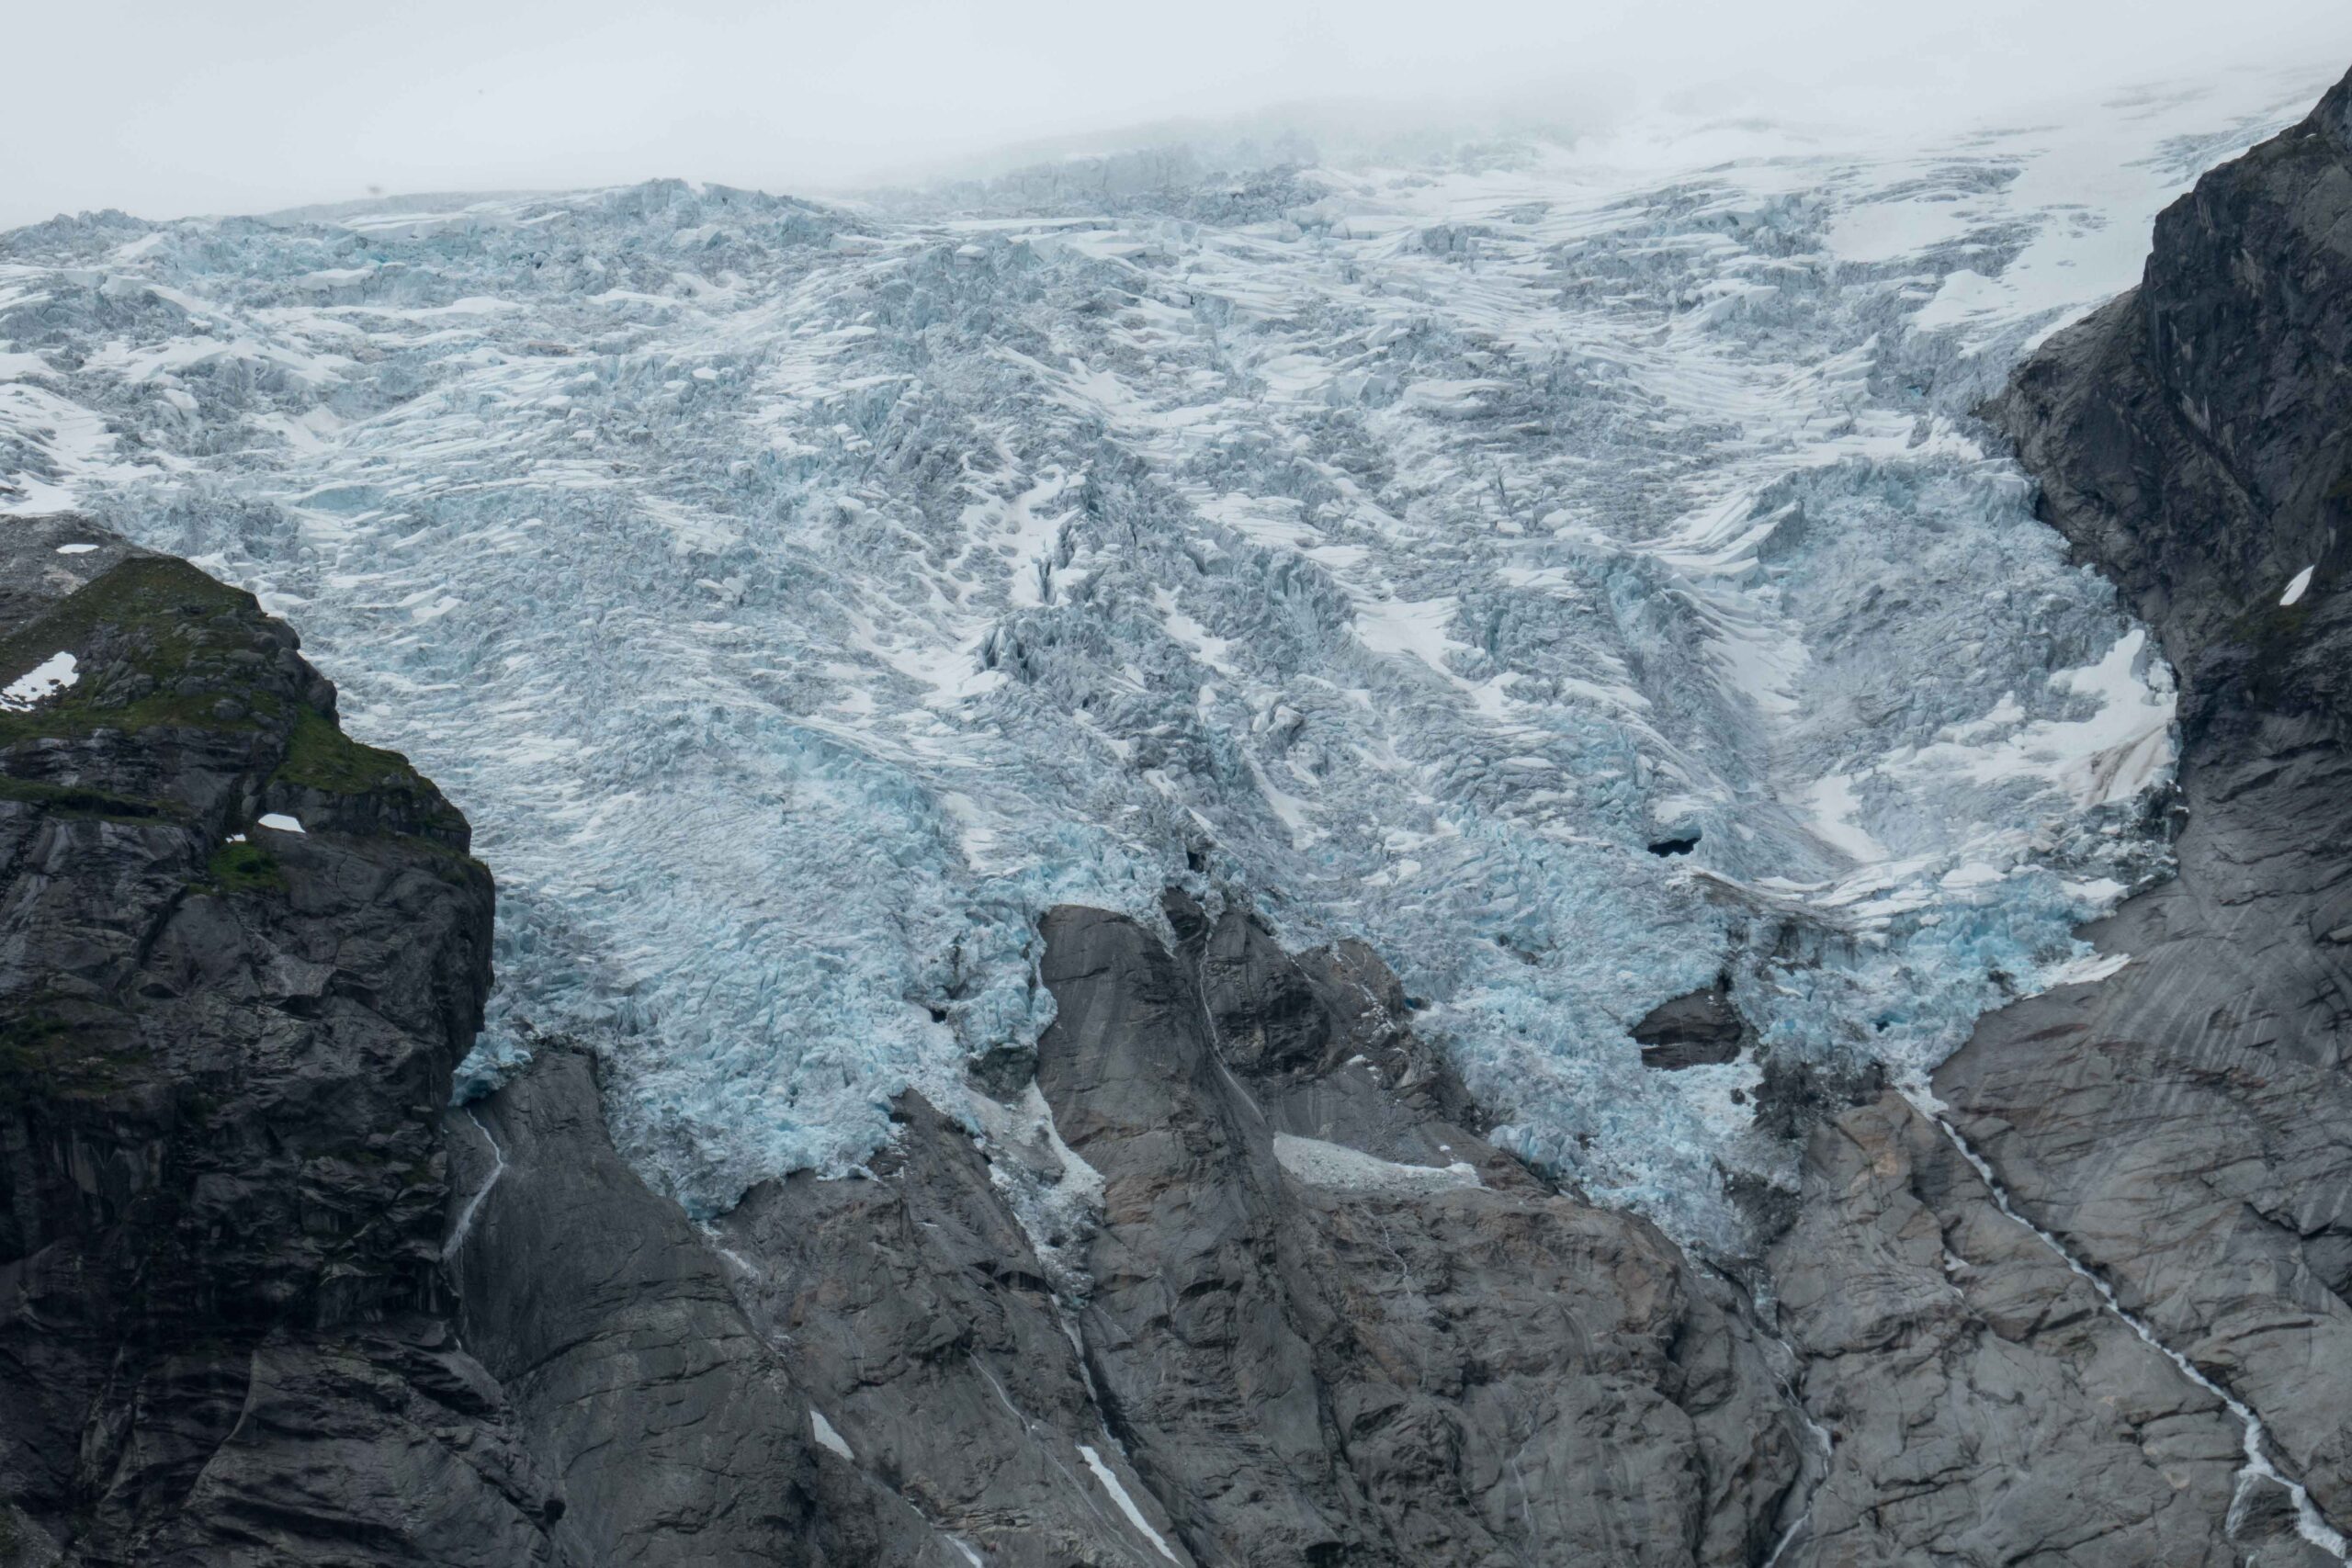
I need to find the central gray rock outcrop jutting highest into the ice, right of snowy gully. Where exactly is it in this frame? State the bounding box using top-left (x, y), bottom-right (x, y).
top-left (1037, 905), bottom-right (1799, 1563)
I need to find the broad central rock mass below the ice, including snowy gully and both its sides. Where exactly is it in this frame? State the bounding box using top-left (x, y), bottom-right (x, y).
top-left (695, 896), bottom-right (1802, 1565)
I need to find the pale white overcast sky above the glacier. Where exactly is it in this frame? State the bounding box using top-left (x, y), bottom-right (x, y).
top-left (14, 0), bottom-right (2352, 228)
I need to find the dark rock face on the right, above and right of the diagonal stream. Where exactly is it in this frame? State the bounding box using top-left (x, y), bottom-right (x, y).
top-left (1936, 64), bottom-right (2352, 1528)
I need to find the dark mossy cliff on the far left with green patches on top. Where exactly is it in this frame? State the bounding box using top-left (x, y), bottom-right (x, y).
top-left (0, 520), bottom-right (555, 1565)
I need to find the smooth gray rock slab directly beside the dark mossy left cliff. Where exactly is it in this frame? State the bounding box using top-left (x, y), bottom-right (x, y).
top-left (447, 1042), bottom-right (962, 1568)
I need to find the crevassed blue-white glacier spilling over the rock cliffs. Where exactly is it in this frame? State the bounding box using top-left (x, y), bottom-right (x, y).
top-left (0, 73), bottom-right (2317, 1251)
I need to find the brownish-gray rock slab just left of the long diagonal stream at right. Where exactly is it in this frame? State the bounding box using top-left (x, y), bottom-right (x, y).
top-left (1771, 1093), bottom-right (2248, 1568)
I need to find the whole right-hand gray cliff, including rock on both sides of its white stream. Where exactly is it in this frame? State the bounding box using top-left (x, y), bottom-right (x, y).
top-left (1771, 55), bottom-right (2352, 1568)
